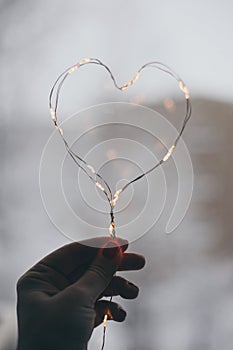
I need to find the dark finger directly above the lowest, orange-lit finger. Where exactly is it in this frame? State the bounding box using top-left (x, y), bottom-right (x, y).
top-left (100, 276), bottom-right (139, 299)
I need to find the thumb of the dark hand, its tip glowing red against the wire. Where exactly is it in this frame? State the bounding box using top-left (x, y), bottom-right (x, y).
top-left (71, 239), bottom-right (128, 303)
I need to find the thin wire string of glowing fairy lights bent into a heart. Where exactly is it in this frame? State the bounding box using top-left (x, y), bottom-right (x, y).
top-left (49, 58), bottom-right (192, 350)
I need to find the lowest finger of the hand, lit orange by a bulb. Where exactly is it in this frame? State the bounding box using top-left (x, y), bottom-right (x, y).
top-left (95, 300), bottom-right (126, 327)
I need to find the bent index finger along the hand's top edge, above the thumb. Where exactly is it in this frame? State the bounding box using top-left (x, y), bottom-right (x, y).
top-left (17, 237), bottom-right (128, 296)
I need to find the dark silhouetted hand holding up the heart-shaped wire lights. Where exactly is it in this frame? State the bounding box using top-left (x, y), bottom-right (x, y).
top-left (17, 237), bottom-right (145, 350)
